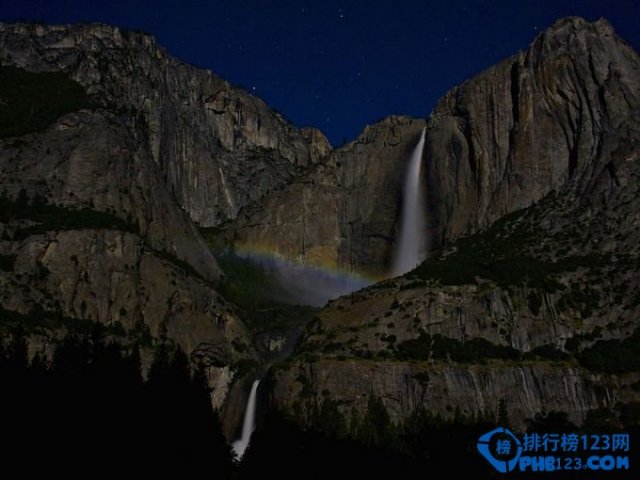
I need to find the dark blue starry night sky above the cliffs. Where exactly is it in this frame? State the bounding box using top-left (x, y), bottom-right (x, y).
top-left (0, 0), bottom-right (640, 144)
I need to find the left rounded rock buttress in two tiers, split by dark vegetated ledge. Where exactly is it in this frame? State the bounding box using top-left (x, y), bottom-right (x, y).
top-left (0, 104), bottom-right (254, 408)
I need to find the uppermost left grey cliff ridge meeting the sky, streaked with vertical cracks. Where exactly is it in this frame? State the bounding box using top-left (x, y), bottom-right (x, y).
top-left (0, 24), bottom-right (331, 226)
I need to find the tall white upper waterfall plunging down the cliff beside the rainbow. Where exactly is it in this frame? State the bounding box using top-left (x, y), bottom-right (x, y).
top-left (392, 129), bottom-right (426, 276)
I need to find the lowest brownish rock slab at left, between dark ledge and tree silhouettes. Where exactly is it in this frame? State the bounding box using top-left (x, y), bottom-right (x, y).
top-left (0, 229), bottom-right (249, 367)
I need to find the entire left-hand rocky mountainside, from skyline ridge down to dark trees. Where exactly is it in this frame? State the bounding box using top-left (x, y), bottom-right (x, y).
top-left (0, 23), bottom-right (331, 418)
